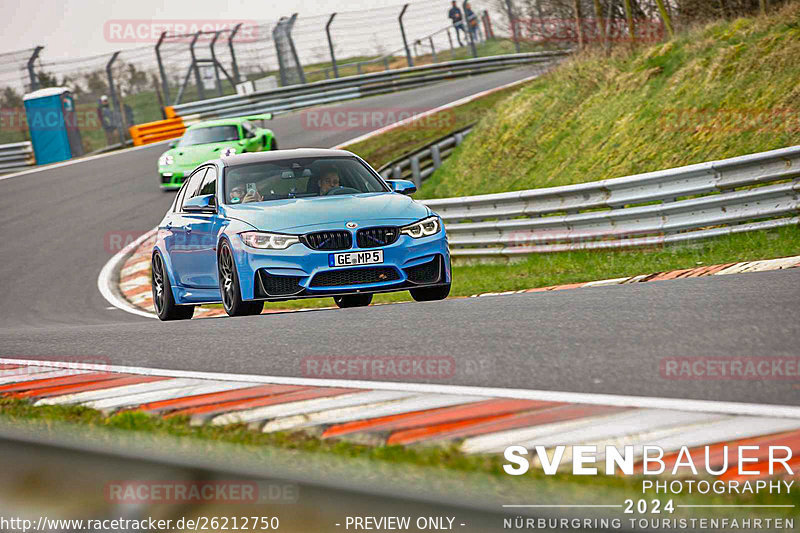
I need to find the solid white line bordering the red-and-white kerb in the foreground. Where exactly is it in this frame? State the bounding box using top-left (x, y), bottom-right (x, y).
top-left (6, 358), bottom-right (800, 419)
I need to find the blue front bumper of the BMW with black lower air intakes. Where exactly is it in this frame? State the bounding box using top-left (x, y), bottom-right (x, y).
top-left (231, 231), bottom-right (451, 301)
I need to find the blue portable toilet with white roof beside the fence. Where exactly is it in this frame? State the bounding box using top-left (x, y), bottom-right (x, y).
top-left (23, 87), bottom-right (83, 165)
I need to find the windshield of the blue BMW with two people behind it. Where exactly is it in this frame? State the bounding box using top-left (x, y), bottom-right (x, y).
top-left (225, 157), bottom-right (389, 204)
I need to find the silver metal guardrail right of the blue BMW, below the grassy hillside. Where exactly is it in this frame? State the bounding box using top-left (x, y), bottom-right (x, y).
top-left (424, 146), bottom-right (800, 258)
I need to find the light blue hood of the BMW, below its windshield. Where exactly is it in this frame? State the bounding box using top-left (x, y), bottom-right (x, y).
top-left (219, 192), bottom-right (430, 233)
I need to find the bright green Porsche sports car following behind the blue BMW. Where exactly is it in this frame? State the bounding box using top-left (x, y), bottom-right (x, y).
top-left (158, 113), bottom-right (278, 191)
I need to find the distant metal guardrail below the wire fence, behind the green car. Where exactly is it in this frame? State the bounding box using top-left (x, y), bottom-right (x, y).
top-left (171, 51), bottom-right (569, 125)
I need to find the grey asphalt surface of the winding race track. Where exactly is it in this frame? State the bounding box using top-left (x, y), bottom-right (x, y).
top-left (0, 69), bottom-right (800, 405)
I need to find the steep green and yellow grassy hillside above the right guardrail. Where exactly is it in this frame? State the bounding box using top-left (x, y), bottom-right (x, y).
top-left (418, 2), bottom-right (800, 198)
